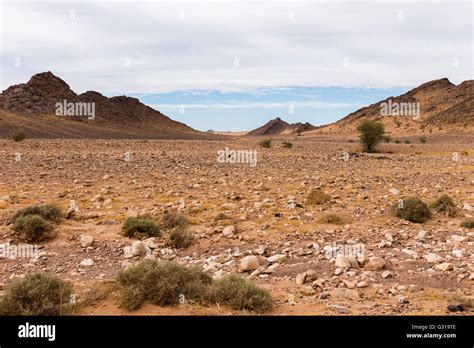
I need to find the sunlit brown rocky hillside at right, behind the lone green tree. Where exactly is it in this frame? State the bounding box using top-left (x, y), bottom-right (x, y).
top-left (331, 78), bottom-right (474, 130)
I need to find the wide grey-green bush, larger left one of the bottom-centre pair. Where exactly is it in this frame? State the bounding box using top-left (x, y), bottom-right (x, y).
top-left (118, 260), bottom-right (212, 310)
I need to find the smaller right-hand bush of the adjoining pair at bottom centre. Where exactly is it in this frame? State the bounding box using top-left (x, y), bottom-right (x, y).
top-left (209, 275), bottom-right (274, 312)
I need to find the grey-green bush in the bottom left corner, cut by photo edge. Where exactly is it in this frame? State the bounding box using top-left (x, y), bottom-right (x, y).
top-left (0, 273), bottom-right (72, 315)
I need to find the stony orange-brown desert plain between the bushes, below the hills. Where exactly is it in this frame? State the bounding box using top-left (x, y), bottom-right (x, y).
top-left (0, 135), bottom-right (474, 315)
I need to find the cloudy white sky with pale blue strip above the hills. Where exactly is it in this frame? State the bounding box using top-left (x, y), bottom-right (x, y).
top-left (0, 0), bottom-right (474, 130)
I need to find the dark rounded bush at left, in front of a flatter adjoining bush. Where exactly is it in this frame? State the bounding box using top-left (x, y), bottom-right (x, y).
top-left (13, 214), bottom-right (54, 243)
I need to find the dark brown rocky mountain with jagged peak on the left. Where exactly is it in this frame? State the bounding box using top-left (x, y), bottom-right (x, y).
top-left (0, 71), bottom-right (222, 139)
